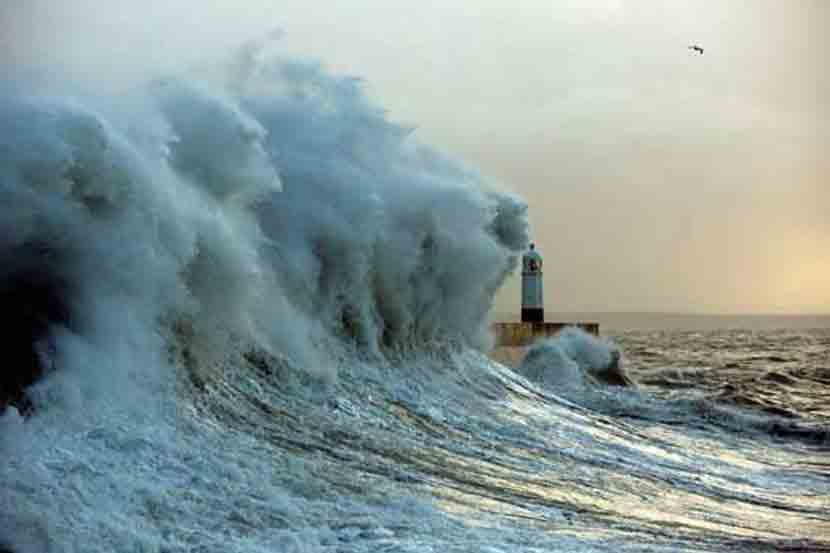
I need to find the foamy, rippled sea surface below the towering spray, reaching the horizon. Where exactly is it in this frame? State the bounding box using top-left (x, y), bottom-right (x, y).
top-left (2, 329), bottom-right (830, 551)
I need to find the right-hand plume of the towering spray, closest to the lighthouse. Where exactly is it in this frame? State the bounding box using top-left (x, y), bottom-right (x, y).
top-left (244, 55), bottom-right (527, 352)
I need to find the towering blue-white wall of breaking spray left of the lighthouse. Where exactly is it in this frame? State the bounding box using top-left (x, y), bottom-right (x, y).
top-left (0, 40), bottom-right (527, 409)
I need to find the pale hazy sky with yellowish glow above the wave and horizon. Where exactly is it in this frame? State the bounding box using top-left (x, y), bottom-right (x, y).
top-left (0, 0), bottom-right (830, 313)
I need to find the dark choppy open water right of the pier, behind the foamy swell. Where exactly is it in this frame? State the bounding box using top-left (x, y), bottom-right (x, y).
top-left (616, 328), bottom-right (830, 424)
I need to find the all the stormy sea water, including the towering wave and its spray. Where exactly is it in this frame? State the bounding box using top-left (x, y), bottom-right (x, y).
top-left (0, 40), bottom-right (830, 553)
